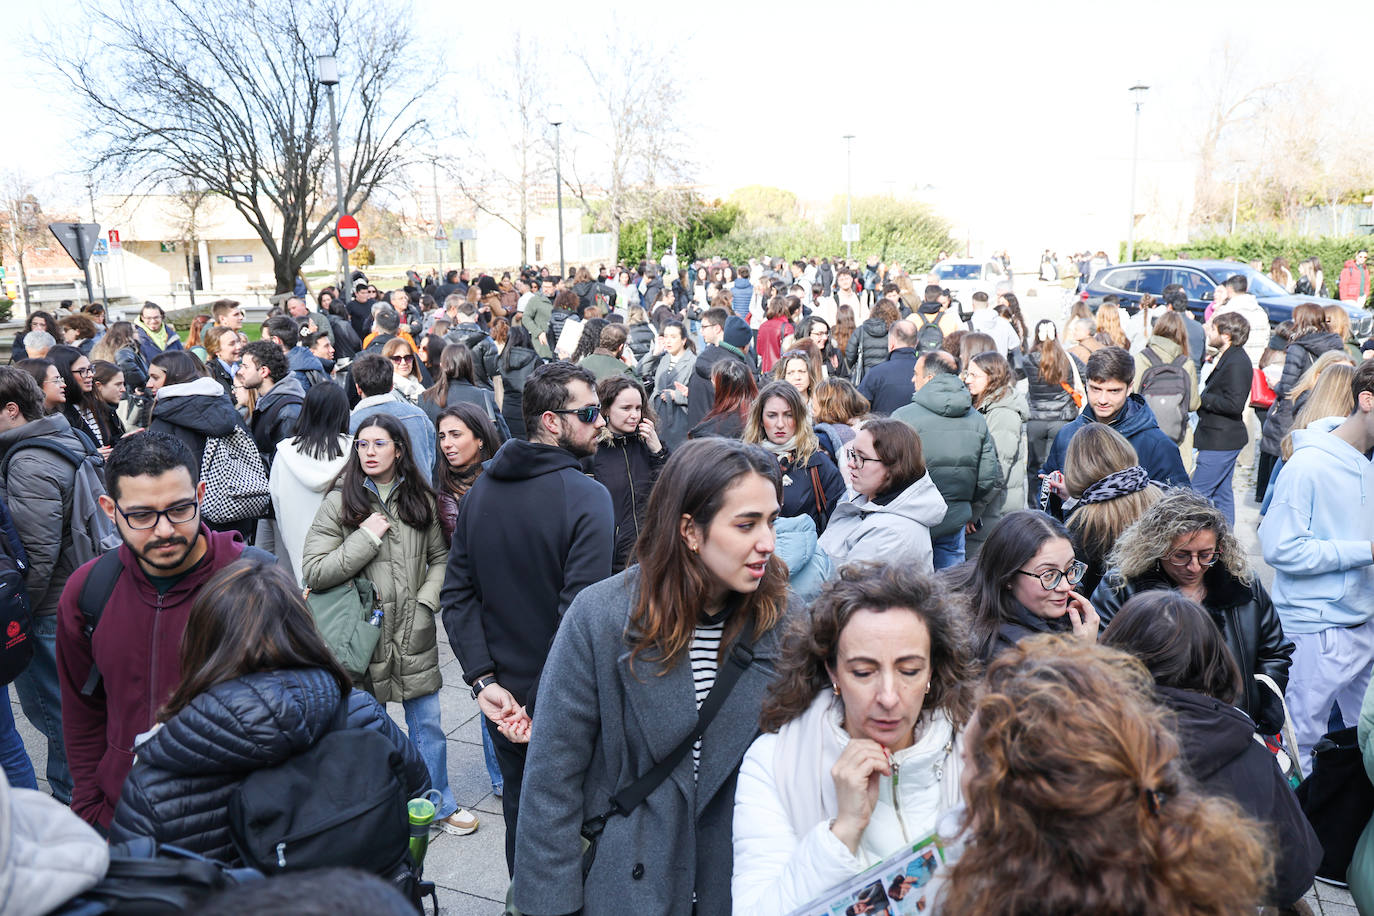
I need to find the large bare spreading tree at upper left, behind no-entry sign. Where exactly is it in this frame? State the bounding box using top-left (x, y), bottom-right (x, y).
top-left (49, 0), bottom-right (429, 293)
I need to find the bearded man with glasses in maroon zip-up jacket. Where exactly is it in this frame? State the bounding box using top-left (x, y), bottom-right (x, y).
top-left (57, 433), bottom-right (269, 829)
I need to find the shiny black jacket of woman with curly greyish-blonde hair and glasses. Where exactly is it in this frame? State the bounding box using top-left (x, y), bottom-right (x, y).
top-left (1092, 563), bottom-right (1293, 735)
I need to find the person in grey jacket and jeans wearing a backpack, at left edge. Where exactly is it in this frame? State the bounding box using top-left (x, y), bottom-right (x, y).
top-left (0, 367), bottom-right (99, 803)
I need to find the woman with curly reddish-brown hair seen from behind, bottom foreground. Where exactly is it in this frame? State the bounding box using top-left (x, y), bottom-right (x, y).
top-left (937, 637), bottom-right (1272, 916)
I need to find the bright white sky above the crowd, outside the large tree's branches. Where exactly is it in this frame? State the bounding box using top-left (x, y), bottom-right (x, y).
top-left (0, 0), bottom-right (1374, 254)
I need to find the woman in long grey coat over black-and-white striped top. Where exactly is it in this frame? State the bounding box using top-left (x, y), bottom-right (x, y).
top-left (511, 438), bottom-right (789, 916)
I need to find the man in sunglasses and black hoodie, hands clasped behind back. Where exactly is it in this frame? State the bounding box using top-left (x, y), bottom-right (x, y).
top-left (440, 363), bottom-right (616, 871)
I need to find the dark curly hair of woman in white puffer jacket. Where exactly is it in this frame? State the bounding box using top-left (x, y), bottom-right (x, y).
top-left (760, 563), bottom-right (974, 732)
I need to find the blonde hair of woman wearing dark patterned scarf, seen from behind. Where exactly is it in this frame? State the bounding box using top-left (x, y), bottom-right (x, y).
top-left (1063, 423), bottom-right (1160, 556)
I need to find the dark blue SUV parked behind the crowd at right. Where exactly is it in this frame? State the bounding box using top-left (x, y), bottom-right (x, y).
top-left (1080, 261), bottom-right (1374, 341)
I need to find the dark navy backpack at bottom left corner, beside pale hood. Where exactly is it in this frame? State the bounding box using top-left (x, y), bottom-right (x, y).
top-left (51, 836), bottom-right (262, 916)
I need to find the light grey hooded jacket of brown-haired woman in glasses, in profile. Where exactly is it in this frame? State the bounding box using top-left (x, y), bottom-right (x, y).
top-left (820, 474), bottom-right (945, 573)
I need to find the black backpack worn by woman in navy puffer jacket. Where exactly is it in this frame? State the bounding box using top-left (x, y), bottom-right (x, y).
top-left (229, 725), bottom-right (437, 909)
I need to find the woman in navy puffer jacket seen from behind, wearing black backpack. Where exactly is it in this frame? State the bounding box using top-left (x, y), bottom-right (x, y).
top-left (110, 558), bottom-right (430, 864)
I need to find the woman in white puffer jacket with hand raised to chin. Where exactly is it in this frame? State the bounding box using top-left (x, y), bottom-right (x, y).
top-left (731, 564), bottom-right (973, 916)
